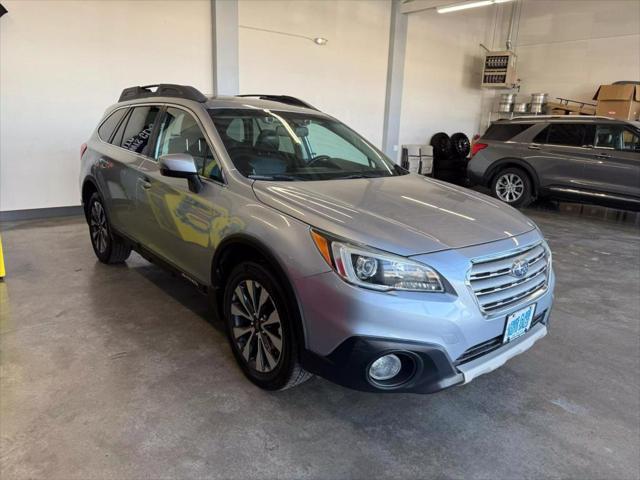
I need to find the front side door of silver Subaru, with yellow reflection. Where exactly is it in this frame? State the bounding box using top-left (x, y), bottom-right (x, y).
top-left (137, 106), bottom-right (229, 283)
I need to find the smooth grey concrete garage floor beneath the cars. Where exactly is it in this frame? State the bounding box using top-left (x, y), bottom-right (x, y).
top-left (0, 205), bottom-right (640, 480)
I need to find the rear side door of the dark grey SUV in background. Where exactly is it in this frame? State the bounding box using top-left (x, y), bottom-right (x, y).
top-left (529, 121), bottom-right (598, 190)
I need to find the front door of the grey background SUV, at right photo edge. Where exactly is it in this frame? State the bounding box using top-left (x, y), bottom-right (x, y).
top-left (593, 123), bottom-right (640, 198)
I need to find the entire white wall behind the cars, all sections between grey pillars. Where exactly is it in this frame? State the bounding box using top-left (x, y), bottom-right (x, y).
top-left (0, 0), bottom-right (640, 211)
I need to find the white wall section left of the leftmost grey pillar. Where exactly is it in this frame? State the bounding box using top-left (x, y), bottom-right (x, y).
top-left (0, 0), bottom-right (212, 211)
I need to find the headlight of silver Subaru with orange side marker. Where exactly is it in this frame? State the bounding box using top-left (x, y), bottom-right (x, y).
top-left (311, 230), bottom-right (444, 292)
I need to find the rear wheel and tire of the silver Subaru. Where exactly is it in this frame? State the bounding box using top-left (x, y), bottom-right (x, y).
top-left (86, 192), bottom-right (131, 264)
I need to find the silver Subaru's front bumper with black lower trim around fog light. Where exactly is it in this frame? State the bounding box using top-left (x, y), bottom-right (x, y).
top-left (296, 231), bottom-right (555, 393)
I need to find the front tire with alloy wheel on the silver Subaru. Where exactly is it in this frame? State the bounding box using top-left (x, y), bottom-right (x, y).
top-left (223, 262), bottom-right (311, 390)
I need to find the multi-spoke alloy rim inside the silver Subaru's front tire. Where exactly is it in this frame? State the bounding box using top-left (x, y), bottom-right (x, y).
top-left (231, 280), bottom-right (283, 373)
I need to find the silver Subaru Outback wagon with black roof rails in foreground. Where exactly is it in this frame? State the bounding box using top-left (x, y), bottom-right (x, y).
top-left (80, 84), bottom-right (555, 393)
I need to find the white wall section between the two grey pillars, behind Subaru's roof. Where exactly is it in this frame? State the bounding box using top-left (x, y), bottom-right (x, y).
top-left (238, 0), bottom-right (391, 147)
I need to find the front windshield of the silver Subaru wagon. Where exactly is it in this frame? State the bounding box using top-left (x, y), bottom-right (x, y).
top-left (209, 108), bottom-right (406, 181)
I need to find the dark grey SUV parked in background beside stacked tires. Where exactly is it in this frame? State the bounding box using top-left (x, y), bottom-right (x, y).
top-left (467, 116), bottom-right (640, 210)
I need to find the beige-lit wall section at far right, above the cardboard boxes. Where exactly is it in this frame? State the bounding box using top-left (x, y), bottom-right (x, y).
top-left (516, 0), bottom-right (640, 101)
